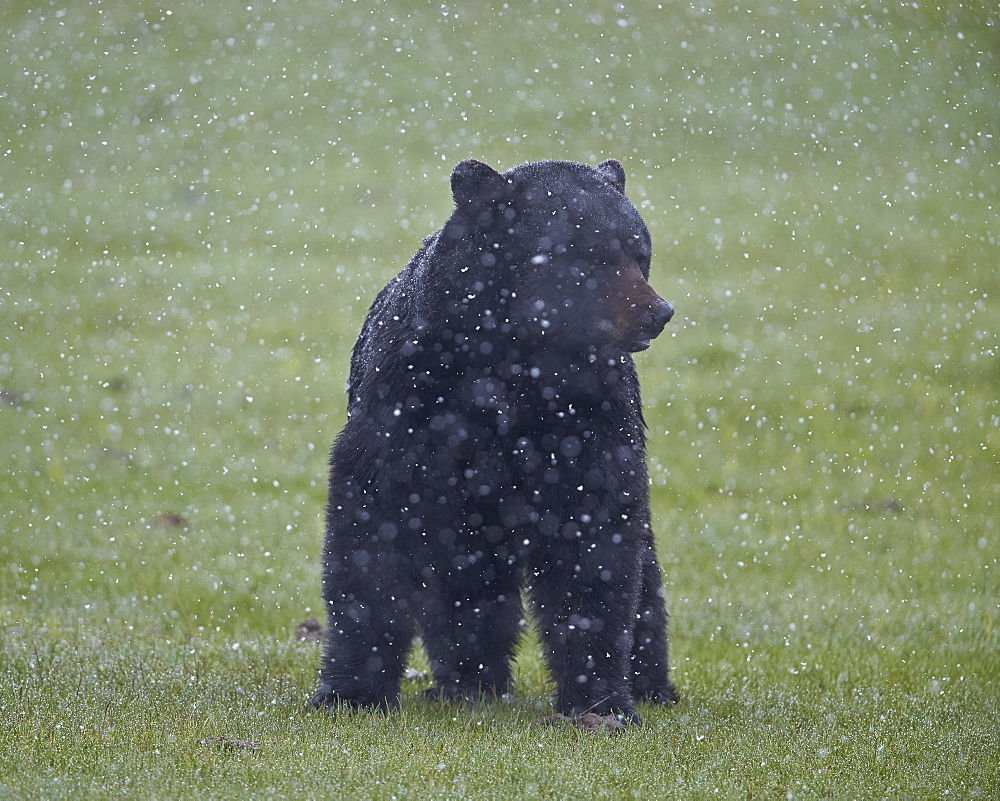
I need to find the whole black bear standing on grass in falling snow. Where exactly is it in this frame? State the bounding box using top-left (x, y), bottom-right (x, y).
top-left (313, 160), bottom-right (677, 723)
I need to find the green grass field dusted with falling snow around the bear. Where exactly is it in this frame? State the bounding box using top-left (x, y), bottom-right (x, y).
top-left (0, 0), bottom-right (1000, 799)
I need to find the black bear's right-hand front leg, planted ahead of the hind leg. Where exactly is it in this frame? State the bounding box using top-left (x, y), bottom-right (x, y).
top-left (531, 539), bottom-right (642, 724)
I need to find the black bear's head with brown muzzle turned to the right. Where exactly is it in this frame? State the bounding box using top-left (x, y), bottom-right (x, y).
top-left (443, 159), bottom-right (673, 352)
